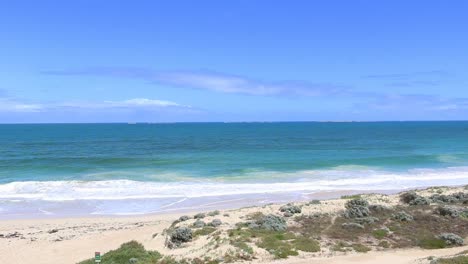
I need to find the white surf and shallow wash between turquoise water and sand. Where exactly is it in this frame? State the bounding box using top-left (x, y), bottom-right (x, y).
top-left (0, 166), bottom-right (468, 219)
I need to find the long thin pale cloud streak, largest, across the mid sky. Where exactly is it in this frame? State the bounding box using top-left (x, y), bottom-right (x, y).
top-left (43, 67), bottom-right (352, 96)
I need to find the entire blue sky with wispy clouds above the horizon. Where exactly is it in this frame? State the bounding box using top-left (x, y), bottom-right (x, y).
top-left (0, 0), bottom-right (468, 123)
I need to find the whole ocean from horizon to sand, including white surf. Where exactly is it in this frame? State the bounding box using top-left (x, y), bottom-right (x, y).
top-left (0, 121), bottom-right (468, 218)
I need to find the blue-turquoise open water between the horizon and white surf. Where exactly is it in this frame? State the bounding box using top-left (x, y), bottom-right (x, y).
top-left (0, 122), bottom-right (468, 183)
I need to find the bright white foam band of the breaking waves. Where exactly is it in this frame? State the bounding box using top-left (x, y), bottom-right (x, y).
top-left (0, 167), bottom-right (468, 201)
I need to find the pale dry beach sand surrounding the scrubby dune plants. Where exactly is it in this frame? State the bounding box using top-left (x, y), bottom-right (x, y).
top-left (0, 187), bottom-right (468, 264)
